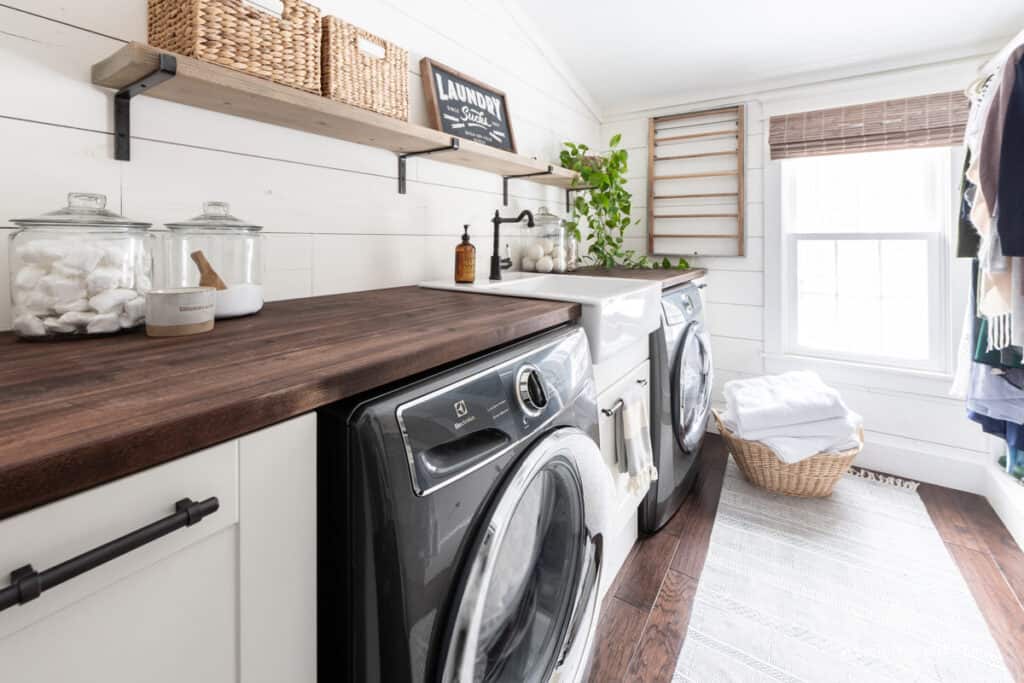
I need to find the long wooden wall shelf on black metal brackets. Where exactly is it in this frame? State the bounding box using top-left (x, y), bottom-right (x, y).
top-left (92, 43), bottom-right (577, 188)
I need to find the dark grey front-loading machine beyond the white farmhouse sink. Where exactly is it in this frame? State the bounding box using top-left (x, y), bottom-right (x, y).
top-left (639, 280), bottom-right (714, 535)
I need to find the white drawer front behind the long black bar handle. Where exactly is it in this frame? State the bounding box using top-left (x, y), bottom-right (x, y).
top-left (0, 441), bottom-right (239, 638)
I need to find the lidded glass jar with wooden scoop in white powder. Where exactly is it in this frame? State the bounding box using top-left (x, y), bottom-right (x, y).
top-left (165, 202), bottom-right (263, 317)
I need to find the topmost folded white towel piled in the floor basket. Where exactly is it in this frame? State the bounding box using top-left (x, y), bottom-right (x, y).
top-left (723, 371), bottom-right (847, 438)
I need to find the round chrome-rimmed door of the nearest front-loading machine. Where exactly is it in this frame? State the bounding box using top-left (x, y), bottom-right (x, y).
top-left (441, 428), bottom-right (610, 683)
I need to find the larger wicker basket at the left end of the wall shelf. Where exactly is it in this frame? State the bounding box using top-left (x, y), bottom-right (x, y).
top-left (148, 0), bottom-right (321, 94)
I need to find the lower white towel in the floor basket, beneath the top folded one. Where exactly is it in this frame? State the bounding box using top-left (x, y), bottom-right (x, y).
top-left (722, 411), bottom-right (863, 464)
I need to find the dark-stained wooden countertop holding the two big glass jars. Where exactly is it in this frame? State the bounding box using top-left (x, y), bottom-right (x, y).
top-left (0, 287), bottom-right (581, 518)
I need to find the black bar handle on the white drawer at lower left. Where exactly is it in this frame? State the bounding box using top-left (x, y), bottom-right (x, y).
top-left (0, 498), bottom-right (220, 611)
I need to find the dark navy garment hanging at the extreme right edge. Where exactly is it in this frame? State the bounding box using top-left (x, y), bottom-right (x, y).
top-left (992, 55), bottom-right (1024, 256)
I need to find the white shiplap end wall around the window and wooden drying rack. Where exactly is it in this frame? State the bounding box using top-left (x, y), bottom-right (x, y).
top-left (601, 52), bottom-right (1024, 507)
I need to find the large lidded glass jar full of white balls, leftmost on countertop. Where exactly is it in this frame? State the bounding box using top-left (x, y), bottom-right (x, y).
top-left (9, 193), bottom-right (153, 339)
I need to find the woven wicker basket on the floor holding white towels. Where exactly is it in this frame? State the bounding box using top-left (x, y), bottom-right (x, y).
top-left (713, 411), bottom-right (864, 498)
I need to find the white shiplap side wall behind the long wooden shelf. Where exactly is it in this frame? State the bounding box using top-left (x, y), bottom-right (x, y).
top-left (0, 0), bottom-right (599, 329)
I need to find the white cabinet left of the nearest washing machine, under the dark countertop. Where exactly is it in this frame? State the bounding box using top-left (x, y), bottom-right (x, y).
top-left (0, 415), bottom-right (316, 683)
